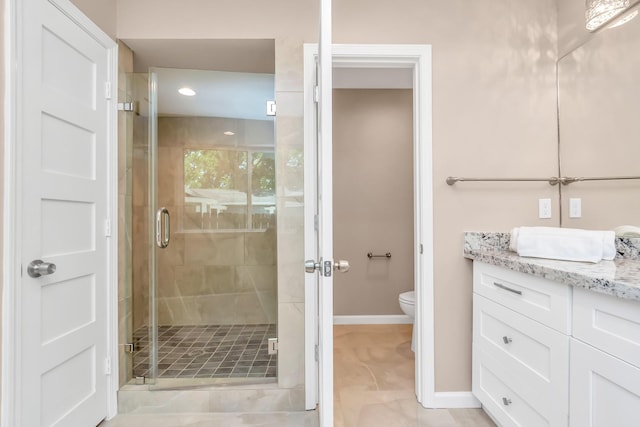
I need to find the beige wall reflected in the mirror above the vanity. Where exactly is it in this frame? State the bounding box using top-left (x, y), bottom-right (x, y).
top-left (558, 1), bottom-right (640, 229)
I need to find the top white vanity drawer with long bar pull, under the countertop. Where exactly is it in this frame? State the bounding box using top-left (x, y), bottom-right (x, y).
top-left (473, 262), bottom-right (571, 335)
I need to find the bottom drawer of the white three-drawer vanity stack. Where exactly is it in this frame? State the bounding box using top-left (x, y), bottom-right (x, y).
top-left (473, 350), bottom-right (568, 427)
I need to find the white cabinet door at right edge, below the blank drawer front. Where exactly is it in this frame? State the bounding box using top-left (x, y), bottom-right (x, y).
top-left (569, 338), bottom-right (640, 427)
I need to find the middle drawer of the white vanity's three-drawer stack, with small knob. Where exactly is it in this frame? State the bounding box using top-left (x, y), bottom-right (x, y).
top-left (473, 294), bottom-right (569, 384)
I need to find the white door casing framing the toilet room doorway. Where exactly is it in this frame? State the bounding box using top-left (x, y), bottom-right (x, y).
top-left (305, 45), bottom-right (434, 409)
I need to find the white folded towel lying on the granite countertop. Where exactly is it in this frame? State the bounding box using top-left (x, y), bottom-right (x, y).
top-left (509, 227), bottom-right (616, 262)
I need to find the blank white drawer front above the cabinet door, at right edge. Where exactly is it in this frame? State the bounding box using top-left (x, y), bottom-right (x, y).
top-left (573, 288), bottom-right (640, 367)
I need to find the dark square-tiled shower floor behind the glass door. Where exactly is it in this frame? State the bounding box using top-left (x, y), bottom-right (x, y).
top-left (133, 325), bottom-right (277, 378)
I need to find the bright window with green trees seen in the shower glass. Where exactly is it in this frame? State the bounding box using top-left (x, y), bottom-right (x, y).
top-left (182, 149), bottom-right (276, 231)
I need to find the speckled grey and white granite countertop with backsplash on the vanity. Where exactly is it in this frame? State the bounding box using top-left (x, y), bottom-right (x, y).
top-left (464, 232), bottom-right (640, 302)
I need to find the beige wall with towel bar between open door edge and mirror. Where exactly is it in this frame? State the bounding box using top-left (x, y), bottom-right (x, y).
top-left (334, 1), bottom-right (558, 391)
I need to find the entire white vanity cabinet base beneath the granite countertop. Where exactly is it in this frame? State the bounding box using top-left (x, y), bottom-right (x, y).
top-left (472, 262), bottom-right (640, 427)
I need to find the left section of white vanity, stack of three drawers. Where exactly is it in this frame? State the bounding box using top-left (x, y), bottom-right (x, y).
top-left (473, 262), bottom-right (571, 427)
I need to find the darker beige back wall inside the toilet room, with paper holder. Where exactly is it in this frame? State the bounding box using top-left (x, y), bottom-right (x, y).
top-left (333, 89), bottom-right (414, 315)
